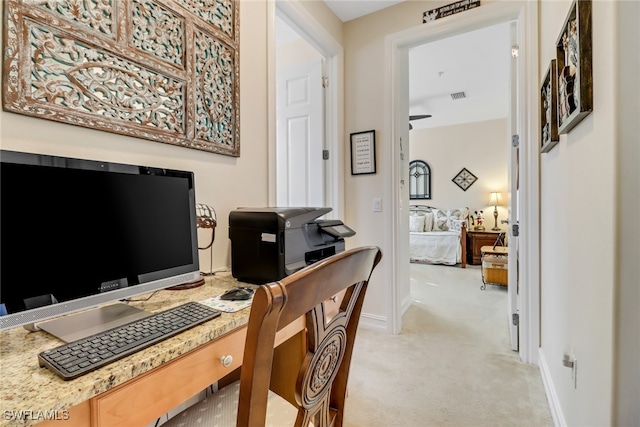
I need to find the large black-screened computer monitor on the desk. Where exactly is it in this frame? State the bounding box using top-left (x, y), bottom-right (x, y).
top-left (0, 150), bottom-right (199, 339)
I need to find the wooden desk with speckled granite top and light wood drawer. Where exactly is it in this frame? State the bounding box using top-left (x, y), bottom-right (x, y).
top-left (0, 274), bottom-right (304, 427)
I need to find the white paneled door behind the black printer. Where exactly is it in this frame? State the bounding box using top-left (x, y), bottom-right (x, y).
top-left (276, 58), bottom-right (325, 207)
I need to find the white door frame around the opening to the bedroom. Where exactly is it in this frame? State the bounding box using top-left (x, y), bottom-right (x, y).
top-left (385, 1), bottom-right (540, 364)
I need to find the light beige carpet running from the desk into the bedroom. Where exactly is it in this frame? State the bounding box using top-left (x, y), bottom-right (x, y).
top-left (345, 264), bottom-right (553, 427)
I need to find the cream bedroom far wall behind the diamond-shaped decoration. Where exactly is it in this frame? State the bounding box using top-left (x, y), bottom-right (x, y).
top-left (409, 118), bottom-right (509, 230)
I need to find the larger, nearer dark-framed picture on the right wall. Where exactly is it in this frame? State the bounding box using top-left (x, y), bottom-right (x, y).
top-left (556, 0), bottom-right (593, 134)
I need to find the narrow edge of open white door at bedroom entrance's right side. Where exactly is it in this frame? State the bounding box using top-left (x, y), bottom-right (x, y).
top-left (507, 23), bottom-right (520, 351)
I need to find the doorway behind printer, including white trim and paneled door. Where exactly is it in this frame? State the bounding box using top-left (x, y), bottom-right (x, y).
top-left (268, 1), bottom-right (344, 218)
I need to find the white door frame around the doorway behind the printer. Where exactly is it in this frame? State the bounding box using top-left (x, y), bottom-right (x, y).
top-left (267, 0), bottom-right (345, 218)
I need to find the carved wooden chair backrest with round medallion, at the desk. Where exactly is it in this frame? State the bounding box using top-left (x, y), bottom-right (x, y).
top-left (237, 246), bottom-right (382, 427)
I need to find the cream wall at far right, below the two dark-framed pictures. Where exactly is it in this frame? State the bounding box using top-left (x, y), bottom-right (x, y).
top-left (538, 0), bottom-right (640, 426)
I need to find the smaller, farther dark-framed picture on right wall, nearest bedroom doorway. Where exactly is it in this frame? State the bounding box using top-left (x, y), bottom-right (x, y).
top-left (540, 59), bottom-right (560, 153)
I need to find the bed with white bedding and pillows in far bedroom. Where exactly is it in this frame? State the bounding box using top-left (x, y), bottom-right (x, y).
top-left (409, 205), bottom-right (468, 268)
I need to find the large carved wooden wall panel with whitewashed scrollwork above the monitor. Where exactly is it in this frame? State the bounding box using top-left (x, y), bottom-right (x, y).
top-left (3, 0), bottom-right (240, 157)
